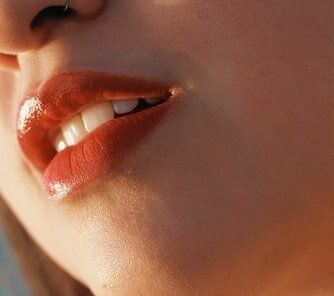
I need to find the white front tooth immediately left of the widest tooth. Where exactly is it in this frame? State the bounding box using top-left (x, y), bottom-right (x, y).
top-left (62, 115), bottom-right (87, 146)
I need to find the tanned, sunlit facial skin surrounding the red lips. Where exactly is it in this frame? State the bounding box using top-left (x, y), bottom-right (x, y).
top-left (0, 0), bottom-right (334, 296)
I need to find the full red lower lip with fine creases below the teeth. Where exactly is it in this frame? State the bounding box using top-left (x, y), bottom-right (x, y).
top-left (44, 98), bottom-right (175, 199)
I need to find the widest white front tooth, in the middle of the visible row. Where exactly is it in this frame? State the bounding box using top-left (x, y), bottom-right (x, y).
top-left (81, 101), bottom-right (114, 132)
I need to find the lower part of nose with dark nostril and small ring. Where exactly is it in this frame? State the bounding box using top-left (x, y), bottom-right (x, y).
top-left (0, 0), bottom-right (105, 55)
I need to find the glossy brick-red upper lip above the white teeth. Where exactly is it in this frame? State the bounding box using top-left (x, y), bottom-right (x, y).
top-left (17, 72), bottom-right (172, 170)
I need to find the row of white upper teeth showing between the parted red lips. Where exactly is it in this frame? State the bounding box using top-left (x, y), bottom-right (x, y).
top-left (54, 99), bottom-right (161, 152)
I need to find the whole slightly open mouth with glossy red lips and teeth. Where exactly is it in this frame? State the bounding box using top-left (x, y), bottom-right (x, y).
top-left (17, 72), bottom-right (181, 199)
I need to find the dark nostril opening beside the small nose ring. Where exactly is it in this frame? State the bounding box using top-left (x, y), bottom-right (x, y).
top-left (30, 5), bottom-right (75, 30)
